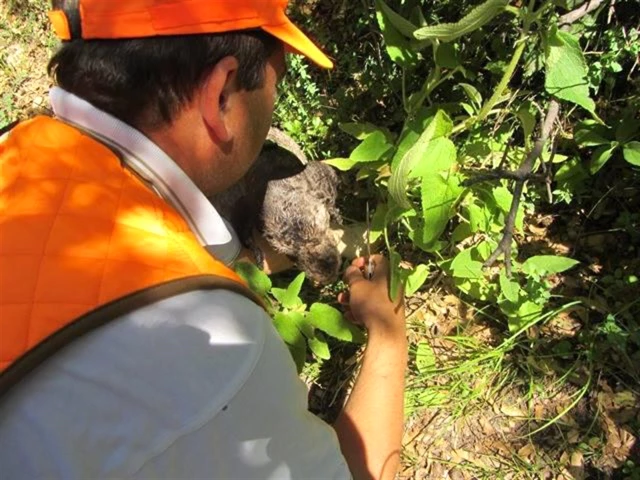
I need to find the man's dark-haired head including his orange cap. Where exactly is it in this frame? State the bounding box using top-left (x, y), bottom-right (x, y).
top-left (49, 0), bottom-right (331, 194)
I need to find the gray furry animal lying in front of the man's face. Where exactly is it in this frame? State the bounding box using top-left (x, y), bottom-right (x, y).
top-left (210, 128), bottom-right (342, 284)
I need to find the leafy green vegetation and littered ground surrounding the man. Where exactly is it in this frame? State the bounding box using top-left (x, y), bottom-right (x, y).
top-left (0, 0), bottom-right (640, 479)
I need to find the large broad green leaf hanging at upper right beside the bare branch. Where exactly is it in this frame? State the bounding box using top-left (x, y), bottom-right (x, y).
top-left (545, 28), bottom-right (596, 113)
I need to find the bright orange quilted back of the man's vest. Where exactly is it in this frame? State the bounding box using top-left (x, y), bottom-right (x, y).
top-left (0, 117), bottom-right (243, 371)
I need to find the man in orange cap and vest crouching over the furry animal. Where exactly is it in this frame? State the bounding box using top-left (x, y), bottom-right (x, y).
top-left (0, 0), bottom-right (407, 480)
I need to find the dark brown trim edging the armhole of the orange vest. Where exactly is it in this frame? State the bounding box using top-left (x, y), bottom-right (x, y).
top-left (0, 274), bottom-right (265, 399)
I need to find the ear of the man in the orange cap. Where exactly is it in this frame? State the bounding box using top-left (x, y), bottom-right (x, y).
top-left (200, 57), bottom-right (238, 143)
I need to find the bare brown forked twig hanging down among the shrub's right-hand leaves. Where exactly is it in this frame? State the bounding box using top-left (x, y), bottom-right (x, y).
top-left (484, 100), bottom-right (560, 276)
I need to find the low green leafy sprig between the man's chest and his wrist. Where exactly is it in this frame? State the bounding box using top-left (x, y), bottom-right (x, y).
top-left (235, 262), bottom-right (364, 372)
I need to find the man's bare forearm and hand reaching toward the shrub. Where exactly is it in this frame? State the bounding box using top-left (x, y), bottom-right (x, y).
top-left (334, 256), bottom-right (408, 480)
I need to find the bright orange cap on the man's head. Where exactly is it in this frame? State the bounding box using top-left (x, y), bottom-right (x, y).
top-left (49, 0), bottom-right (333, 68)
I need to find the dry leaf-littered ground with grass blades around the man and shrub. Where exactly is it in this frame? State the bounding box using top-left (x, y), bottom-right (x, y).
top-left (0, 0), bottom-right (640, 479)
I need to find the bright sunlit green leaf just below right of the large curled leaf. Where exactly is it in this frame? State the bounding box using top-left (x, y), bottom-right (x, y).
top-left (421, 173), bottom-right (464, 245)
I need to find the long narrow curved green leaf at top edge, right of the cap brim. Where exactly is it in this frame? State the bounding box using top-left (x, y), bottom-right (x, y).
top-left (413, 0), bottom-right (509, 42)
